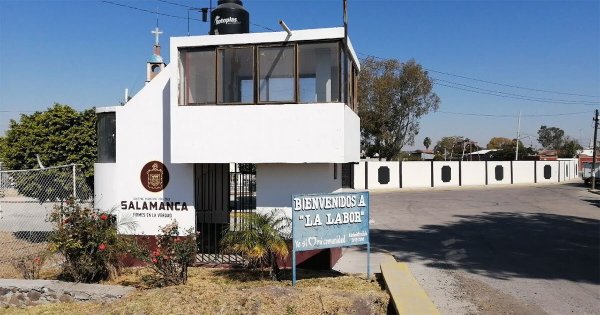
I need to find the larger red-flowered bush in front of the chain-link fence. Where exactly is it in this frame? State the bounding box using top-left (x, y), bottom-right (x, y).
top-left (48, 199), bottom-right (129, 282)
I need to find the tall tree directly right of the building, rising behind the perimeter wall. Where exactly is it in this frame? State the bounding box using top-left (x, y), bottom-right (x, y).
top-left (358, 57), bottom-right (440, 160)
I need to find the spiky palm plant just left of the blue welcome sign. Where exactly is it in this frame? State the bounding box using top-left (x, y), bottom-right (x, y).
top-left (221, 211), bottom-right (290, 280)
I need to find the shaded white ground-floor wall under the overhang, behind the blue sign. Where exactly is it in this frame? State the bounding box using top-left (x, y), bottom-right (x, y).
top-left (256, 163), bottom-right (342, 217)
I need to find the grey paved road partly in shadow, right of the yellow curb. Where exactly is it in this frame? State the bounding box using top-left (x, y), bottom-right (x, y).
top-left (371, 184), bottom-right (600, 314)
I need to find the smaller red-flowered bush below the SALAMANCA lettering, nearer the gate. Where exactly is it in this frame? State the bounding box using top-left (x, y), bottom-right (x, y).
top-left (137, 220), bottom-right (197, 287)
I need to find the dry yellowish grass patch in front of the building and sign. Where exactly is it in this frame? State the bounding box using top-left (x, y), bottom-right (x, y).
top-left (7, 267), bottom-right (389, 315)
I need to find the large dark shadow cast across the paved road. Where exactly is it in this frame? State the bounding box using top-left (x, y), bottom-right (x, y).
top-left (371, 212), bottom-right (600, 284)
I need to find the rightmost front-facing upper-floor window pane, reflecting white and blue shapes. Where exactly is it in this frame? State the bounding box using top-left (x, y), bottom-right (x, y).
top-left (298, 42), bottom-right (340, 103)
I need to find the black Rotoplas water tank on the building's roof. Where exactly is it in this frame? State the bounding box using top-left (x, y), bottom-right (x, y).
top-left (210, 0), bottom-right (250, 35)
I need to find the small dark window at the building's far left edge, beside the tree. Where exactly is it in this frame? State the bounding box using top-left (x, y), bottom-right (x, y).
top-left (96, 112), bottom-right (117, 163)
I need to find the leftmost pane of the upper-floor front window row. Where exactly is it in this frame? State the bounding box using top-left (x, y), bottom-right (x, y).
top-left (180, 49), bottom-right (216, 105)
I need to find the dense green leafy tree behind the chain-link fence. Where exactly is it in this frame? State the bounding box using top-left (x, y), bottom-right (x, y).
top-left (0, 103), bottom-right (96, 197)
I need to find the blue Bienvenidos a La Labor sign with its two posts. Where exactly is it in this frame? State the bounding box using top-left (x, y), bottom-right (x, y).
top-left (292, 191), bottom-right (371, 286)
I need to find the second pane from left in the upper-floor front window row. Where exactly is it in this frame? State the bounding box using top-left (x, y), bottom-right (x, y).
top-left (217, 47), bottom-right (254, 104)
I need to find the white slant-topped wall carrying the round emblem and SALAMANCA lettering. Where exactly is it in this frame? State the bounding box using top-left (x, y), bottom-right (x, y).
top-left (95, 65), bottom-right (195, 235)
